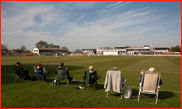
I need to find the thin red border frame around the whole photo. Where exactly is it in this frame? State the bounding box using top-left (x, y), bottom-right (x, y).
top-left (0, 0), bottom-right (182, 109)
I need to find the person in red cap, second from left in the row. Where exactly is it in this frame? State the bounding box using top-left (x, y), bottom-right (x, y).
top-left (33, 64), bottom-right (47, 81)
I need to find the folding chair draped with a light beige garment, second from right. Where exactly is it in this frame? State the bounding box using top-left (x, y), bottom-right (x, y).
top-left (104, 70), bottom-right (127, 99)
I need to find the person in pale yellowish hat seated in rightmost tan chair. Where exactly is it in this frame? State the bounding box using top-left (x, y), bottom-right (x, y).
top-left (139, 67), bottom-right (163, 85)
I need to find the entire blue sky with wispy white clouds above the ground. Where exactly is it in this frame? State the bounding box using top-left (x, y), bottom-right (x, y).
top-left (1, 1), bottom-right (181, 51)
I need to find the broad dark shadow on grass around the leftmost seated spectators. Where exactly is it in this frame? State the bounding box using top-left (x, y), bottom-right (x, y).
top-left (1, 63), bottom-right (84, 84)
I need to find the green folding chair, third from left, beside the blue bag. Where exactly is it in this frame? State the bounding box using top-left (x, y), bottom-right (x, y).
top-left (56, 68), bottom-right (69, 86)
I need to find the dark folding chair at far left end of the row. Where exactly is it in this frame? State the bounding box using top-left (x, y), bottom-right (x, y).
top-left (14, 66), bottom-right (25, 81)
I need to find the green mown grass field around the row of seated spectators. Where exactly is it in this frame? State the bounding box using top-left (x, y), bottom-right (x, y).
top-left (1, 56), bottom-right (181, 108)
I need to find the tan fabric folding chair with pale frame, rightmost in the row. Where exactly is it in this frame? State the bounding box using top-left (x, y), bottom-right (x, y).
top-left (138, 72), bottom-right (161, 104)
